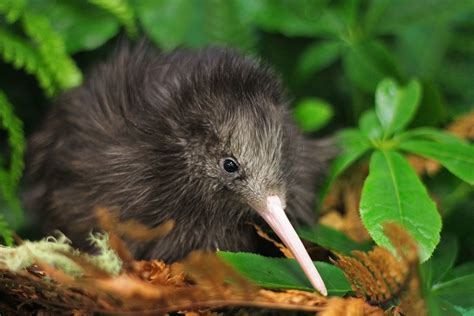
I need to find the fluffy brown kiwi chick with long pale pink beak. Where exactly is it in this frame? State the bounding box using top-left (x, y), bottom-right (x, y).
top-left (25, 44), bottom-right (331, 294)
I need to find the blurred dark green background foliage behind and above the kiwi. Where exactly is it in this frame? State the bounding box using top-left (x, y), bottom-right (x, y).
top-left (0, 0), bottom-right (474, 274)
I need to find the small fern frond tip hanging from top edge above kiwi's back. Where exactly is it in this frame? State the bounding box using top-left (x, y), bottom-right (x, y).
top-left (89, 0), bottom-right (137, 37)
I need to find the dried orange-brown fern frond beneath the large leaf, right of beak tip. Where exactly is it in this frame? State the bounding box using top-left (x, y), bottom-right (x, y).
top-left (335, 224), bottom-right (426, 315)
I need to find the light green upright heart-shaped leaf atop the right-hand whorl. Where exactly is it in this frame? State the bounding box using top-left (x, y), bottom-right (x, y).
top-left (375, 79), bottom-right (421, 138)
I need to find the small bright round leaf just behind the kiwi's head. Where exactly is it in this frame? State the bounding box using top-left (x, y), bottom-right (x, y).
top-left (293, 98), bottom-right (334, 132)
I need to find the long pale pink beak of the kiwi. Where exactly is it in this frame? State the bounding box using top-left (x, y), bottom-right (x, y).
top-left (259, 195), bottom-right (328, 296)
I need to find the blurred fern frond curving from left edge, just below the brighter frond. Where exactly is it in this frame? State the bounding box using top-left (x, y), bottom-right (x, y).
top-left (0, 30), bottom-right (56, 96)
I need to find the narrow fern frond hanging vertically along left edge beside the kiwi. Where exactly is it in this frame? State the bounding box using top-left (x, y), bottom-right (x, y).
top-left (0, 91), bottom-right (26, 224)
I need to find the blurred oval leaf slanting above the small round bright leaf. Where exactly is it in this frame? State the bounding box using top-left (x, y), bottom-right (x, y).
top-left (297, 41), bottom-right (341, 76)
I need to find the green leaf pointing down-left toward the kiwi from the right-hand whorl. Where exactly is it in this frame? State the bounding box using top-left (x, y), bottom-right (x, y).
top-left (321, 129), bottom-right (371, 199)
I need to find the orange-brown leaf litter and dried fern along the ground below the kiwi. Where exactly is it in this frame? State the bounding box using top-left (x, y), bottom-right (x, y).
top-left (0, 210), bottom-right (424, 315)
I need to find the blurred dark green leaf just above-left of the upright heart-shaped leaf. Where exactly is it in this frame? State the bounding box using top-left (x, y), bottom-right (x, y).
top-left (343, 41), bottom-right (399, 94)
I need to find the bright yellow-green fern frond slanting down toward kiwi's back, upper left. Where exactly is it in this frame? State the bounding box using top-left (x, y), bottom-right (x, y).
top-left (22, 13), bottom-right (82, 90)
